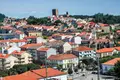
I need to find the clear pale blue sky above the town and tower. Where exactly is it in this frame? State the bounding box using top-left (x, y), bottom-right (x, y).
top-left (0, 0), bottom-right (120, 18)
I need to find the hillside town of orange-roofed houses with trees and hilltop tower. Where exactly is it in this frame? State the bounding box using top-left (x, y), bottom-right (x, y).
top-left (0, 9), bottom-right (120, 80)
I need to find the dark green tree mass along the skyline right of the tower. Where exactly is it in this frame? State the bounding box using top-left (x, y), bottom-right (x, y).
top-left (71, 13), bottom-right (120, 24)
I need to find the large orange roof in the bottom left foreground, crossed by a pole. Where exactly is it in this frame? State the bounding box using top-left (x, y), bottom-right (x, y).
top-left (3, 68), bottom-right (66, 80)
